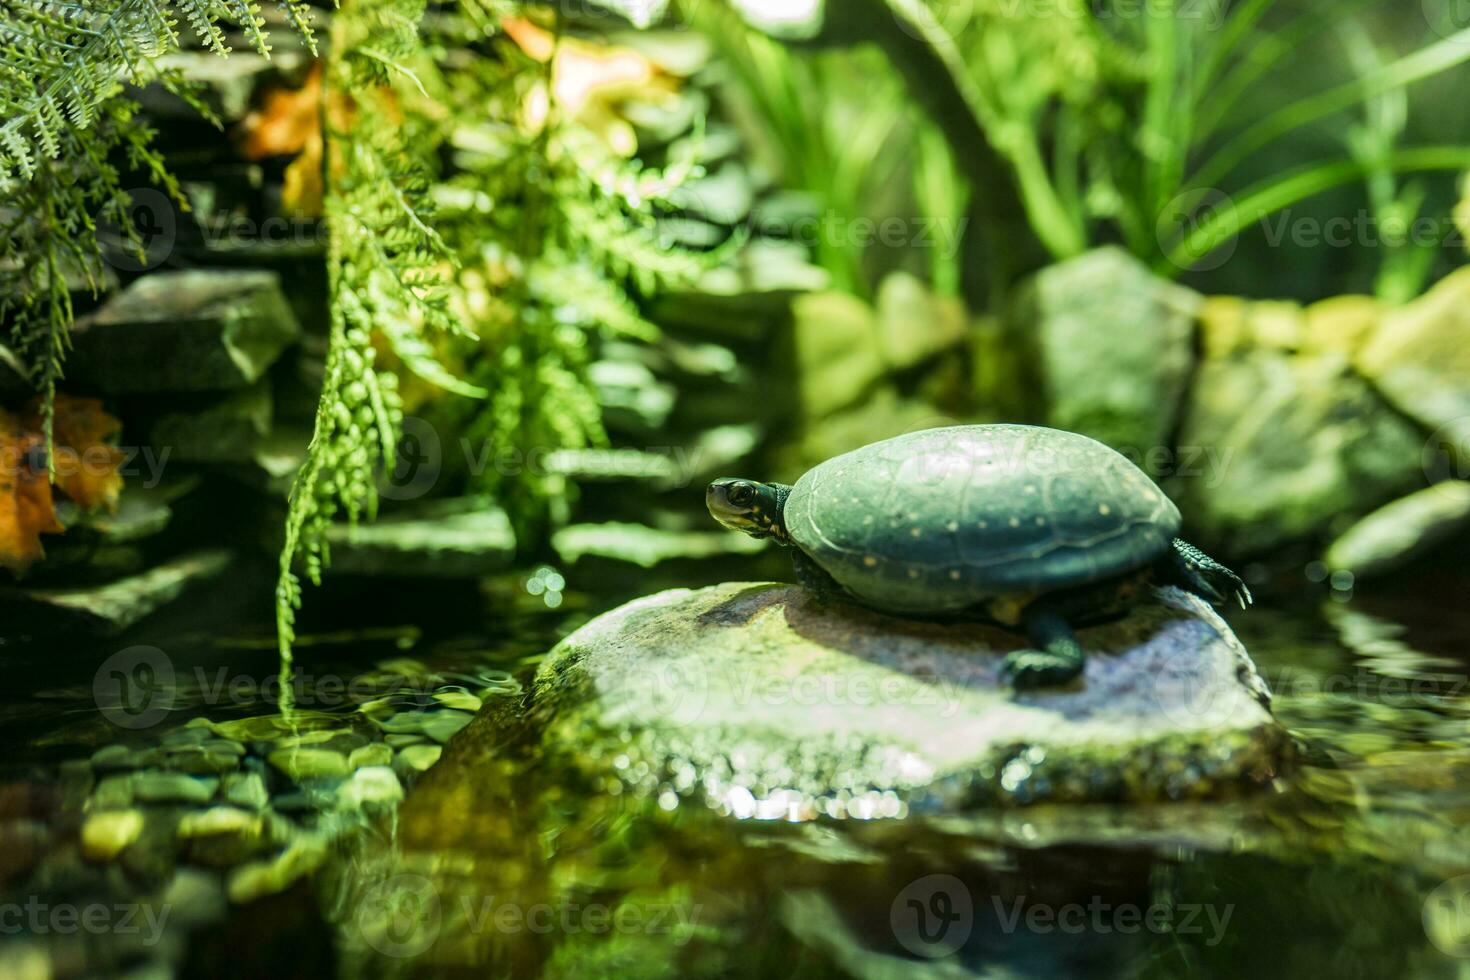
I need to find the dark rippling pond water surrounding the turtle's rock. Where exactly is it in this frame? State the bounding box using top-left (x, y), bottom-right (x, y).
top-left (0, 563), bottom-right (1470, 977)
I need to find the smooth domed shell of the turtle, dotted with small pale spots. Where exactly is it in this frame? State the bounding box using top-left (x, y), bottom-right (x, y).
top-left (785, 425), bottom-right (1179, 613)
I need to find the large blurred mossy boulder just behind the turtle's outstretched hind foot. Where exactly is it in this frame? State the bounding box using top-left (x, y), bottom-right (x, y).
top-left (1170, 350), bottom-right (1423, 554)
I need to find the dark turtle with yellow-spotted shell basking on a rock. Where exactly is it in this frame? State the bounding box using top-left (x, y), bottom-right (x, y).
top-left (706, 425), bottom-right (1251, 689)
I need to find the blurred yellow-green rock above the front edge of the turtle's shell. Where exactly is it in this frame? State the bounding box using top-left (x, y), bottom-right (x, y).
top-left (792, 292), bottom-right (886, 420)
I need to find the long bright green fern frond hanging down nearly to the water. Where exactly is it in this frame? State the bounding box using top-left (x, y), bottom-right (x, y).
top-left (276, 0), bottom-right (455, 669)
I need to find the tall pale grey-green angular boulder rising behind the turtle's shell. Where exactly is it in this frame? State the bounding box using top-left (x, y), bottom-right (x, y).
top-left (1005, 247), bottom-right (1202, 451)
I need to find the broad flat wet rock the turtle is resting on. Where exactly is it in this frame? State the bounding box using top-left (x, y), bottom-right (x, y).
top-left (535, 583), bottom-right (1289, 820)
